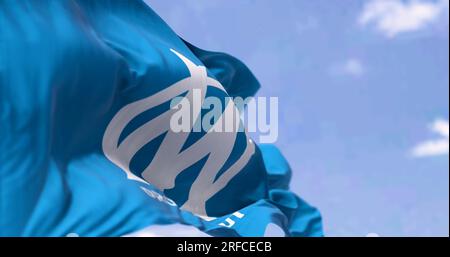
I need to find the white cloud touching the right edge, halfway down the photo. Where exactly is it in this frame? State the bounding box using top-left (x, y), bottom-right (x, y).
top-left (412, 119), bottom-right (449, 157)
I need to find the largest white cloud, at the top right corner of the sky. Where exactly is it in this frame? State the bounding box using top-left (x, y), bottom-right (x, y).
top-left (358, 0), bottom-right (449, 38)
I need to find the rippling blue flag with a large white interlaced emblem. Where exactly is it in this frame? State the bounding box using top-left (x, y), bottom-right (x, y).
top-left (0, 0), bottom-right (322, 236)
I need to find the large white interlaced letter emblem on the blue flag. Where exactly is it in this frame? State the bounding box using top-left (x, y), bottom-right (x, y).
top-left (102, 49), bottom-right (255, 216)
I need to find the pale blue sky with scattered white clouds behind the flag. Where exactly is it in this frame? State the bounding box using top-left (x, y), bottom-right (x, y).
top-left (146, 0), bottom-right (449, 236)
